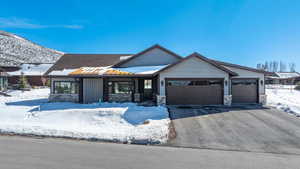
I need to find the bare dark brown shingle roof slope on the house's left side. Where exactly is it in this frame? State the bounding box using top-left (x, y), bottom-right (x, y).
top-left (45, 54), bottom-right (132, 75)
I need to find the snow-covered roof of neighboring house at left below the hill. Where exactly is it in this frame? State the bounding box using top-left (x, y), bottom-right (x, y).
top-left (8, 63), bottom-right (53, 76)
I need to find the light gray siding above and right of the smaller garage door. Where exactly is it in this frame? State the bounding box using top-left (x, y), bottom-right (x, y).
top-left (226, 66), bottom-right (265, 94)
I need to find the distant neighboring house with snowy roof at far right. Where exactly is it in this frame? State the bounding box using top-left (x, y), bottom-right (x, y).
top-left (266, 72), bottom-right (300, 85)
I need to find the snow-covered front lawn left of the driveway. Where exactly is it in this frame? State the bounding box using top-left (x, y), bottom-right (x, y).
top-left (0, 89), bottom-right (170, 143)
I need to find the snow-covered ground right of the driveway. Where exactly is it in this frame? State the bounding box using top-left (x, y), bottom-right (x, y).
top-left (266, 88), bottom-right (300, 117)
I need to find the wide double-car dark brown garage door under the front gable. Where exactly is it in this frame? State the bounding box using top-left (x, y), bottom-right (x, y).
top-left (166, 79), bottom-right (223, 105)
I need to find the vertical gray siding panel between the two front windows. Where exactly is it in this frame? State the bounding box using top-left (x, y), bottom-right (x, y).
top-left (83, 78), bottom-right (103, 103)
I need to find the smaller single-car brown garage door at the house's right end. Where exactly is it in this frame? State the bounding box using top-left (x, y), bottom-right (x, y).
top-left (231, 79), bottom-right (258, 103)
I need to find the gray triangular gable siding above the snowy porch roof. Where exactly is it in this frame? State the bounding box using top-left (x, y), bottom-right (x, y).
top-left (120, 48), bottom-right (179, 67)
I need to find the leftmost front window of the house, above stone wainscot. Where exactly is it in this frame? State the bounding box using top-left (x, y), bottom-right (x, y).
top-left (54, 81), bottom-right (78, 94)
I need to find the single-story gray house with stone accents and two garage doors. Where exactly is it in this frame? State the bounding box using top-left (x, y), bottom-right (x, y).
top-left (46, 45), bottom-right (268, 105)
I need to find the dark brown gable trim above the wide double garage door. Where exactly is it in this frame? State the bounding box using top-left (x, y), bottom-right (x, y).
top-left (154, 52), bottom-right (238, 76)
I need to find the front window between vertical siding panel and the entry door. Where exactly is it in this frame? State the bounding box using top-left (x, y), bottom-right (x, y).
top-left (108, 81), bottom-right (133, 94)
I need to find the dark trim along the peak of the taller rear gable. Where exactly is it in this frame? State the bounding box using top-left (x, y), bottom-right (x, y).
top-left (113, 44), bottom-right (182, 67)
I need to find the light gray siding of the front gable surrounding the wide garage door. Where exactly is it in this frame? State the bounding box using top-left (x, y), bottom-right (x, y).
top-left (159, 57), bottom-right (229, 96)
